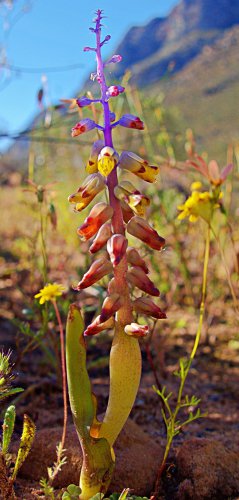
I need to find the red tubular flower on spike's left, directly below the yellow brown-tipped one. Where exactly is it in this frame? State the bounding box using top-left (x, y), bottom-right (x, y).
top-left (77, 202), bottom-right (114, 241)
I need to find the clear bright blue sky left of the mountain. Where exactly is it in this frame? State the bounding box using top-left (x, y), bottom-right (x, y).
top-left (0, 0), bottom-right (178, 150)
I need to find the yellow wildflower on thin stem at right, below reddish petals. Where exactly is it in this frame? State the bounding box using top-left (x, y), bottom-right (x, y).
top-left (178, 191), bottom-right (219, 223)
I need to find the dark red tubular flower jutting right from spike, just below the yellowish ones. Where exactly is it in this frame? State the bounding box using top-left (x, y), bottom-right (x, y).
top-left (127, 216), bottom-right (165, 250)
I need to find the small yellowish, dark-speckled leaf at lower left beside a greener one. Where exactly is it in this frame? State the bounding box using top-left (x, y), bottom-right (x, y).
top-left (12, 415), bottom-right (36, 480)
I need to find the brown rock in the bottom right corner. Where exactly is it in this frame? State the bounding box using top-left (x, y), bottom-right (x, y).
top-left (176, 438), bottom-right (239, 500)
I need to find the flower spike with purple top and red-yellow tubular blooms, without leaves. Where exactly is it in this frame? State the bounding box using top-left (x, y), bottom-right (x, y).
top-left (66, 10), bottom-right (166, 338)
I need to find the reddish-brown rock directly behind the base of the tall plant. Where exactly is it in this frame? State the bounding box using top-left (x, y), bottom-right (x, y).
top-left (19, 420), bottom-right (163, 496)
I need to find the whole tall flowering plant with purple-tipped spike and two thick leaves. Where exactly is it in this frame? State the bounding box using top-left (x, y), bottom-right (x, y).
top-left (66, 10), bottom-right (166, 500)
